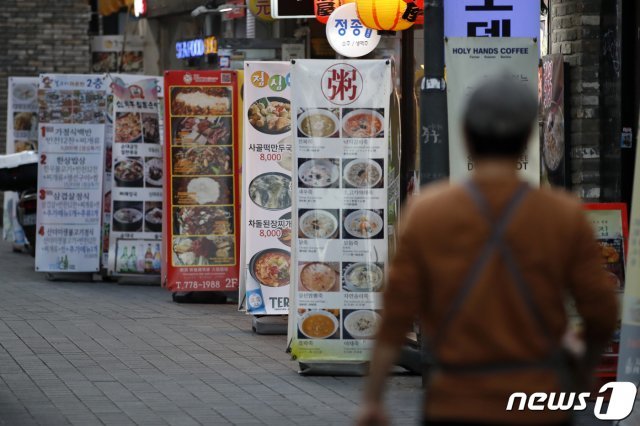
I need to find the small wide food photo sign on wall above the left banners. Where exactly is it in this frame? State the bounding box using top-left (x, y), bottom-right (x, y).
top-left (91, 35), bottom-right (144, 74)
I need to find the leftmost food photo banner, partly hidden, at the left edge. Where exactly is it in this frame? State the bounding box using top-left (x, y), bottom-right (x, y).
top-left (2, 77), bottom-right (38, 246)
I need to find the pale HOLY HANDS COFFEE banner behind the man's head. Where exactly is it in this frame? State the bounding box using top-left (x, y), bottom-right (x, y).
top-left (444, 37), bottom-right (540, 185)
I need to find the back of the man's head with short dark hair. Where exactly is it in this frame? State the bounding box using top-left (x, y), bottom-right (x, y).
top-left (463, 75), bottom-right (538, 158)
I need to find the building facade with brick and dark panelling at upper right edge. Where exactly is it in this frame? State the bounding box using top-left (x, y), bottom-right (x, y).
top-left (546, 0), bottom-right (639, 203)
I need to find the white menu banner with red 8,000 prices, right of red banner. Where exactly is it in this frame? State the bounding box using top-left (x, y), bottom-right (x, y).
top-left (241, 62), bottom-right (293, 315)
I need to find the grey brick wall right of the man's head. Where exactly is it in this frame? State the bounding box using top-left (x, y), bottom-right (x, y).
top-left (551, 0), bottom-right (620, 201)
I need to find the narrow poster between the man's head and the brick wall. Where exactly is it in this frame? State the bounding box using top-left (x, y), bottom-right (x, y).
top-left (540, 53), bottom-right (569, 187)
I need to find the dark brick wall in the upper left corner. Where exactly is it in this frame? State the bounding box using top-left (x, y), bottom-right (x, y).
top-left (0, 0), bottom-right (91, 153)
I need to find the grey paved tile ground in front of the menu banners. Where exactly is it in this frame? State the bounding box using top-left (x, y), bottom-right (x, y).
top-left (0, 243), bottom-right (616, 426)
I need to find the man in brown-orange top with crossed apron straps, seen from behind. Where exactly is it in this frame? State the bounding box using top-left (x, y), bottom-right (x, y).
top-left (358, 78), bottom-right (618, 426)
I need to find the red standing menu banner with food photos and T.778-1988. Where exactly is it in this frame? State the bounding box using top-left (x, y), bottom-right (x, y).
top-left (162, 71), bottom-right (240, 292)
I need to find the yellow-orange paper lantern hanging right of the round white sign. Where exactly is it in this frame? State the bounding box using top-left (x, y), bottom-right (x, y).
top-left (356, 0), bottom-right (417, 31)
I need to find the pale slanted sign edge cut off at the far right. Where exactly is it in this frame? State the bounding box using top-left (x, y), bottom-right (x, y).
top-left (618, 118), bottom-right (640, 388)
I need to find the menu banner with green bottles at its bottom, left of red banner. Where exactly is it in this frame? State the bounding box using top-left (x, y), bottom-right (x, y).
top-left (109, 78), bottom-right (164, 275)
